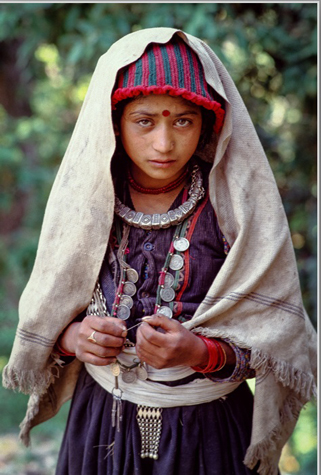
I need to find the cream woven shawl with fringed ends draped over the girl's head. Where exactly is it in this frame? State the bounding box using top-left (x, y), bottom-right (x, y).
top-left (3, 28), bottom-right (316, 475)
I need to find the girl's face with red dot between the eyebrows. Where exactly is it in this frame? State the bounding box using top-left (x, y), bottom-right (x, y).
top-left (116, 94), bottom-right (202, 188)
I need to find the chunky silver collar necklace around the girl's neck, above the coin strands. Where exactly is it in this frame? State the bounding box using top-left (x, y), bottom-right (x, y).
top-left (115, 165), bottom-right (205, 231)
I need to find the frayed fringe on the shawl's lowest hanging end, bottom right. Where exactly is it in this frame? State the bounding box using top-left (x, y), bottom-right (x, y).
top-left (244, 395), bottom-right (303, 475)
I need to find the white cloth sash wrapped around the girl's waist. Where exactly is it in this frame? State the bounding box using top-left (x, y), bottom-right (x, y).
top-left (85, 349), bottom-right (241, 407)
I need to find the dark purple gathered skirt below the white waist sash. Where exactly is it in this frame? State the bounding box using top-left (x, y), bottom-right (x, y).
top-left (56, 369), bottom-right (257, 475)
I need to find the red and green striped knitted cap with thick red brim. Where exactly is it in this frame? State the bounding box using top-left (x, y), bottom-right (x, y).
top-left (112, 36), bottom-right (224, 132)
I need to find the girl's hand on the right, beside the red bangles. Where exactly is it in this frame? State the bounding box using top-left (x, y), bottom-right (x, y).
top-left (136, 315), bottom-right (208, 369)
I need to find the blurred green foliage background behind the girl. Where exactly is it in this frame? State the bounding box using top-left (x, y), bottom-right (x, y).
top-left (0, 2), bottom-right (317, 475)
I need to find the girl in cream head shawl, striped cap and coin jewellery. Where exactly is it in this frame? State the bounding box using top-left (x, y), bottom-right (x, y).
top-left (4, 28), bottom-right (315, 475)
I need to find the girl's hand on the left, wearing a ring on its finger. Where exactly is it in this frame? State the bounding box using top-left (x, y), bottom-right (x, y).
top-left (59, 315), bottom-right (127, 366)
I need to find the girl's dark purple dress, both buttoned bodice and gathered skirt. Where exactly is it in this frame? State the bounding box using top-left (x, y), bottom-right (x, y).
top-left (56, 163), bottom-right (257, 475)
